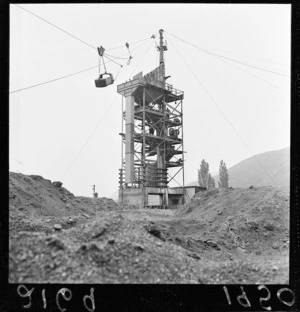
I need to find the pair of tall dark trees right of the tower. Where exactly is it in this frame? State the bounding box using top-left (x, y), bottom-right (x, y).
top-left (198, 159), bottom-right (229, 188)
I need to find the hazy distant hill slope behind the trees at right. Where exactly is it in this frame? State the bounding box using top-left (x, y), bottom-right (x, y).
top-left (190, 147), bottom-right (290, 190)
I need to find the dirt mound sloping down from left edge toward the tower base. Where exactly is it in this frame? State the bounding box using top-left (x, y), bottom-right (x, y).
top-left (9, 172), bottom-right (118, 216)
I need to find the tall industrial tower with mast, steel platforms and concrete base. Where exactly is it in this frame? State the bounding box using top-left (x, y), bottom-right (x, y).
top-left (117, 29), bottom-right (185, 208)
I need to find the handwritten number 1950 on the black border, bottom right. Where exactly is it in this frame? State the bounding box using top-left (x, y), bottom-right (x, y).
top-left (223, 285), bottom-right (295, 311)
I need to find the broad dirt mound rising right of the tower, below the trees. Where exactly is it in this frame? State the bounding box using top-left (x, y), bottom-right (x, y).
top-left (175, 187), bottom-right (289, 255)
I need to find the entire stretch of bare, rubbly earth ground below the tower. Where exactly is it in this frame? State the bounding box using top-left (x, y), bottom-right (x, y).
top-left (9, 172), bottom-right (289, 284)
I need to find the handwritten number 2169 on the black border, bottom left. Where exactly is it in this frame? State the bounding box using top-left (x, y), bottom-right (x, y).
top-left (17, 285), bottom-right (95, 312)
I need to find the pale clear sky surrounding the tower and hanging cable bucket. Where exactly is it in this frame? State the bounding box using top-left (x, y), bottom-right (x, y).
top-left (9, 3), bottom-right (291, 197)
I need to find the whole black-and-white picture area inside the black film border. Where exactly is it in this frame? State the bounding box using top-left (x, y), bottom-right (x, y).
top-left (8, 3), bottom-right (292, 285)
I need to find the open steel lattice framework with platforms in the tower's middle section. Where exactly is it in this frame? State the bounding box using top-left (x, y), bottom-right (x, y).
top-left (120, 81), bottom-right (184, 188)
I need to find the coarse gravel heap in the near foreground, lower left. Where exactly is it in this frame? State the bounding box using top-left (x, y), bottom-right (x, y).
top-left (9, 212), bottom-right (203, 283)
